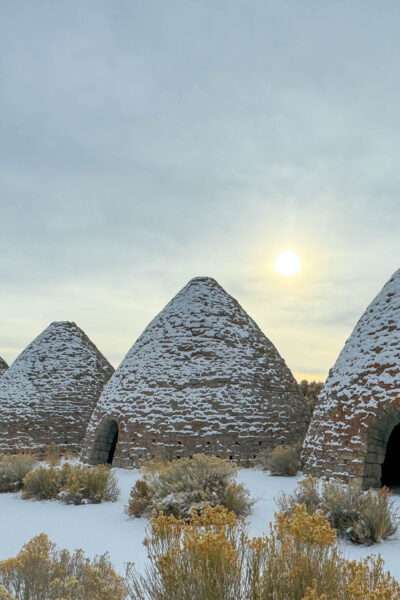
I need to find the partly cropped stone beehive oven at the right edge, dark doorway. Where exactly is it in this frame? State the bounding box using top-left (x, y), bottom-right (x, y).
top-left (303, 270), bottom-right (400, 487)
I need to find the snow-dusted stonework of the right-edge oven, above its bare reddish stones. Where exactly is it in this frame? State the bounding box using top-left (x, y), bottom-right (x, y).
top-left (305, 269), bottom-right (400, 476)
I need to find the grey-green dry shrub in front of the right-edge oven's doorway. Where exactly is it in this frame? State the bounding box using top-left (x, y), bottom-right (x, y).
top-left (279, 477), bottom-right (398, 545)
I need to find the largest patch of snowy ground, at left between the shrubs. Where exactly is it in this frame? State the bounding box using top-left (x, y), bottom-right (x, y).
top-left (0, 469), bottom-right (147, 572)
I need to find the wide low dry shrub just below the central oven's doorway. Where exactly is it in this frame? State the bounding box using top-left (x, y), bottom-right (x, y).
top-left (22, 463), bottom-right (119, 505)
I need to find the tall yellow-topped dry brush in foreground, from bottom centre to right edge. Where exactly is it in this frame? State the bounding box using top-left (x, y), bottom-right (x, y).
top-left (127, 505), bottom-right (400, 600)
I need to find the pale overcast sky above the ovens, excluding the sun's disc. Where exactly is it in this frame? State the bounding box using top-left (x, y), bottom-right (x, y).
top-left (0, 0), bottom-right (400, 379)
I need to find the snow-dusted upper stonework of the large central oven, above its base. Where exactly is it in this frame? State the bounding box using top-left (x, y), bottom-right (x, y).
top-left (83, 277), bottom-right (305, 460)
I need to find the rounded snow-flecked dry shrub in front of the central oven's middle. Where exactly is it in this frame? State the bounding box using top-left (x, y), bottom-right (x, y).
top-left (128, 454), bottom-right (252, 519)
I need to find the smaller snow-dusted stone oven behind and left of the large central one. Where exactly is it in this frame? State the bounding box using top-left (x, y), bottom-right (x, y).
top-left (0, 322), bottom-right (114, 453)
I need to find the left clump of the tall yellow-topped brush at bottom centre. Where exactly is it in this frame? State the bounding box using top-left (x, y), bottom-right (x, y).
top-left (127, 507), bottom-right (245, 600)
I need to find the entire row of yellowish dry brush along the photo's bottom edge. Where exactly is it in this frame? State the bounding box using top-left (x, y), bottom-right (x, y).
top-left (0, 505), bottom-right (400, 600)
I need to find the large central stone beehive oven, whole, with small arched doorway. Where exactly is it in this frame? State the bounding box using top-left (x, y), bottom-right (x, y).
top-left (83, 277), bottom-right (307, 467)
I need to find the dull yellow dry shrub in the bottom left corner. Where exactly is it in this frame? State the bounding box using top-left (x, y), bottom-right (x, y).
top-left (0, 534), bottom-right (127, 600)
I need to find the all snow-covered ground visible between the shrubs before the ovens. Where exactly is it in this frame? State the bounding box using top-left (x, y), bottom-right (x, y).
top-left (0, 469), bottom-right (400, 579)
